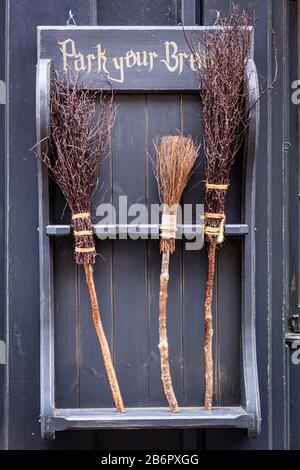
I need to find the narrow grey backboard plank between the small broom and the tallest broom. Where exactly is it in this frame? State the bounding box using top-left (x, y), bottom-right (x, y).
top-left (182, 94), bottom-right (206, 406)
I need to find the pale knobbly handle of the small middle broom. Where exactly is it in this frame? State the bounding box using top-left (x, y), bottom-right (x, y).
top-left (158, 250), bottom-right (178, 413)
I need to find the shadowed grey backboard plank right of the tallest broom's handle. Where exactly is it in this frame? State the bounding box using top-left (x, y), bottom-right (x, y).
top-left (215, 142), bottom-right (241, 406)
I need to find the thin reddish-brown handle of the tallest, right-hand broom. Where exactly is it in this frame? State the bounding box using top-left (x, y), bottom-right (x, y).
top-left (204, 242), bottom-right (216, 411)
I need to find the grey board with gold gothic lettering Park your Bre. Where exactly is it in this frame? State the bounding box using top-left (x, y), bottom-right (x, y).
top-left (39, 27), bottom-right (209, 91)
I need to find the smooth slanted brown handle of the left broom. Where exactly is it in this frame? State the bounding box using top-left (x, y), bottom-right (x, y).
top-left (84, 263), bottom-right (125, 413)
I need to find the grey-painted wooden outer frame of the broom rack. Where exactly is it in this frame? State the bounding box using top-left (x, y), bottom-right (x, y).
top-left (37, 27), bottom-right (260, 439)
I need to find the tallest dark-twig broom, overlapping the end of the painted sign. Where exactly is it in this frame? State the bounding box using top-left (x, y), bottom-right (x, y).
top-left (190, 4), bottom-right (251, 410)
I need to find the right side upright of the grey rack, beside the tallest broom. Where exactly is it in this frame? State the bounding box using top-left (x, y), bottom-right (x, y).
top-left (242, 60), bottom-right (261, 437)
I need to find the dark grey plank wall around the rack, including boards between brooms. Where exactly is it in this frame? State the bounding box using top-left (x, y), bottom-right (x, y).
top-left (0, 0), bottom-right (300, 449)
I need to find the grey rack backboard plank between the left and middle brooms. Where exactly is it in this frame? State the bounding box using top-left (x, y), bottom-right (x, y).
top-left (112, 95), bottom-right (148, 406)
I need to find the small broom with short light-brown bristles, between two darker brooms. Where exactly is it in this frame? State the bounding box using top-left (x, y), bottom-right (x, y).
top-left (154, 136), bottom-right (199, 412)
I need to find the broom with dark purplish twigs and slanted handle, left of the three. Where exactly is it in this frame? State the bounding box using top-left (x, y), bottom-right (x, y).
top-left (41, 74), bottom-right (125, 412)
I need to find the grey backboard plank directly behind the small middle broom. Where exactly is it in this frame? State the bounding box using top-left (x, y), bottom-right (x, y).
top-left (148, 94), bottom-right (183, 406)
